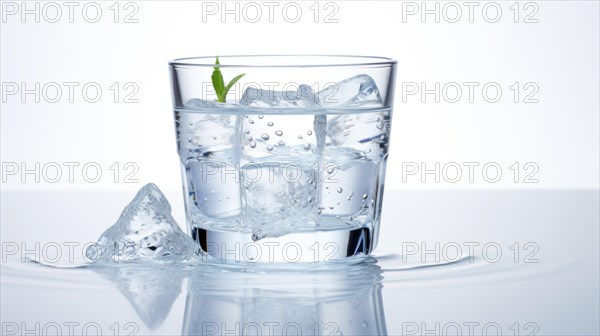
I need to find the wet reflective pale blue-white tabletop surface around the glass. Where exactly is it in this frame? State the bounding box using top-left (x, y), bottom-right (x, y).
top-left (0, 190), bottom-right (600, 335)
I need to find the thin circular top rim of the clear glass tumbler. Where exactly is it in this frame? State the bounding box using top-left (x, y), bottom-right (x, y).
top-left (169, 54), bottom-right (397, 68)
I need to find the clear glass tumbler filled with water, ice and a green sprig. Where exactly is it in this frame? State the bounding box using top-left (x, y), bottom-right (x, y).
top-left (169, 55), bottom-right (396, 263)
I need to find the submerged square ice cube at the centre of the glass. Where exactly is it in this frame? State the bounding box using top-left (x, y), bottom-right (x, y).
top-left (241, 158), bottom-right (317, 240)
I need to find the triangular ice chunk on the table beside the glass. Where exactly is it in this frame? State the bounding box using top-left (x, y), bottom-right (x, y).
top-left (86, 183), bottom-right (198, 264)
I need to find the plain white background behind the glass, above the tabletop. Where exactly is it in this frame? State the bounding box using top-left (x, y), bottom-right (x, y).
top-left (0, 1), bottom-right (600, 192)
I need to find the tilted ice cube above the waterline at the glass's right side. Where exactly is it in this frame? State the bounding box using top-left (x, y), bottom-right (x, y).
top-left (317, 75), bottom-right (383, 108)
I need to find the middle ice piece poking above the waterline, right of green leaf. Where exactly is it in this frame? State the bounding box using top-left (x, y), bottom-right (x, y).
top-left (240, 84), bottom-right (319, 108)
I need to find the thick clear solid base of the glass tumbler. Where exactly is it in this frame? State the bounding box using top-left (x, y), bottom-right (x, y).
top-left (192, 227), bottom-right (374, 265)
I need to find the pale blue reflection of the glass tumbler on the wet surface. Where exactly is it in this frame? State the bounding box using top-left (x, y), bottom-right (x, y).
top-left (182, 259), bottom-right (387, 335)
